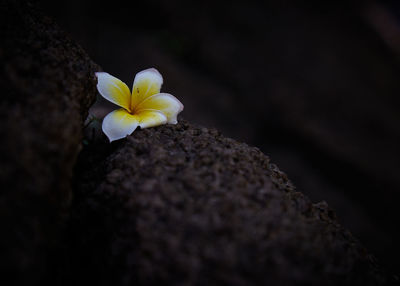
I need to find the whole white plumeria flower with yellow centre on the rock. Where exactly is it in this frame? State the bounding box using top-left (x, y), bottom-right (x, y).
top-left (96, 68), bottom-right (183, 142)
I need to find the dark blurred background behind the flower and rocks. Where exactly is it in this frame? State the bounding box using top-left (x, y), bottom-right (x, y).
top-left (37, 0), bottom-right (400, 273)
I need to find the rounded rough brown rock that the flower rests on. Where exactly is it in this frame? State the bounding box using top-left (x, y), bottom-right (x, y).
top-left (69, 121), bottom-right (385, 285)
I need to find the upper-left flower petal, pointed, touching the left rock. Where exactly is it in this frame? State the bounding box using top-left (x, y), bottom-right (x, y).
top-left (96, 72), bottom-right (131, 111)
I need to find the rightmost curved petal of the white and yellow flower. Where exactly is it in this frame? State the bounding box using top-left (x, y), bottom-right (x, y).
top-left (136, 93), bottom-right (183, 124)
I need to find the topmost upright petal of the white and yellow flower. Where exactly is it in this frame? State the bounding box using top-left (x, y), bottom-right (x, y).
top-left (131, 68), bottom-right (163, 109)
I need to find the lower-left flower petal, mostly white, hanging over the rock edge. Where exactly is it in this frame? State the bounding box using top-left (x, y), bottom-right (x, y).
top-left (102, 108), bottom-right (139, 142)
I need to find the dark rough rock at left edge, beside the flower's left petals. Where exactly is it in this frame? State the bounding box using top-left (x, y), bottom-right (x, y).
top-left (0, 1), bottom-right (98, 285)
